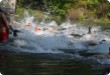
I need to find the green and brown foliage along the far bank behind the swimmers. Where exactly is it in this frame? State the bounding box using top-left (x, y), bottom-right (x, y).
top-left (17, 0), bottom-right (110, 22)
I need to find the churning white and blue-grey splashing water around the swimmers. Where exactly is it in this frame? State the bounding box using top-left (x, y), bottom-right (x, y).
top-left (0, 12), bottom-right (110, 63)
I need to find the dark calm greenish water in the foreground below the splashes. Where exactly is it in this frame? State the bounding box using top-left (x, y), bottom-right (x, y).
top-left (0, 55), bottom-right (103, 75)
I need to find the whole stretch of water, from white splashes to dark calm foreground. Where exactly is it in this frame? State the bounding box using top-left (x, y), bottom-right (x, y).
top-left (0, 12), bottom-right (110, 75)
